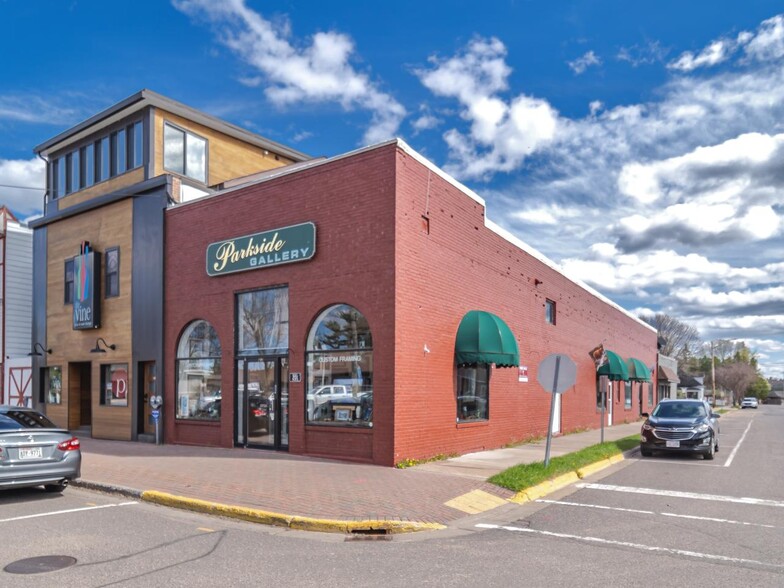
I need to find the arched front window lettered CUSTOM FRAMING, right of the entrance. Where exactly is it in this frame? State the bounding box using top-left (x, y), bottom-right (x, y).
top-left (305, 304), bottom-right (373, 427)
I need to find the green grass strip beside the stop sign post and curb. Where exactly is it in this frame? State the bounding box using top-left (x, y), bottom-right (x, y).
top-left (488, 435), bottom-right (640, 492)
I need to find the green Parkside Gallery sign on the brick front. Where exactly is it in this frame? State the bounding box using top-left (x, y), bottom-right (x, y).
top-left (207, 223), bottom-right (316, 276)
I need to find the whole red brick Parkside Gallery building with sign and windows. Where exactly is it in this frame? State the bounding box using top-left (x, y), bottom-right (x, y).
top-left (163, 140), bottom-right (657, 465)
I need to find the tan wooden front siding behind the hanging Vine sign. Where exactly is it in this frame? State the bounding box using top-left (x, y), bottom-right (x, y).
top-left (46, 199), bottom-right (133, 440)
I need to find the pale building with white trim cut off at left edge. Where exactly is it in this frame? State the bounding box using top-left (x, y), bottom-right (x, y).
top-left (0, 206), bottom-right (33, 406)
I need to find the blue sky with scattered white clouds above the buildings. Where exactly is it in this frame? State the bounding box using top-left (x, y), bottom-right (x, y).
top-left (0, 0), bottom-right (784, 377)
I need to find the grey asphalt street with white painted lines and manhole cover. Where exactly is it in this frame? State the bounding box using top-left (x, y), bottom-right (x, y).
top-left (0, 406), bottom-right (784, 587)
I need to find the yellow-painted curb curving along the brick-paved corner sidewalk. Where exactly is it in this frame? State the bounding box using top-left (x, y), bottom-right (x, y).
top-left (141, 490), bottom-right (446, 535)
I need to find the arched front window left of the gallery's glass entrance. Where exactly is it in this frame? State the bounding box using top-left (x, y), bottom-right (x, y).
top-left (176, 320), bottom-right (221, 421)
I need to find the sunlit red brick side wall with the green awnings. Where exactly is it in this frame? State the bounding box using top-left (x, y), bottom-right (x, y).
top-left (394, 150), bottom-right (656, 462)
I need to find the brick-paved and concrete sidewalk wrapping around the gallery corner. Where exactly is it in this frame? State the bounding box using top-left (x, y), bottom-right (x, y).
top-left (75, 422), bottom-right (640, 532)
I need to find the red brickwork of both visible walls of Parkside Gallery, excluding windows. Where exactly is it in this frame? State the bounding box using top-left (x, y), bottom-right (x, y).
top-left (165, 144), bottom-right (656, 465)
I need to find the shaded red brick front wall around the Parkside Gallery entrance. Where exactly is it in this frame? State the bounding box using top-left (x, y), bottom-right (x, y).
top-left (165, 148), bottom-right (395, 463)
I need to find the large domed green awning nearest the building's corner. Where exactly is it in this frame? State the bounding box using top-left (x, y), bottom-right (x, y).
top-left (455, 310), bottom-right (520, 367)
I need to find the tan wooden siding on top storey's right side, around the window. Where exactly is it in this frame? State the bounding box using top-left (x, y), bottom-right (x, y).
top-left (153, 110), bottom-right (293, 186)
